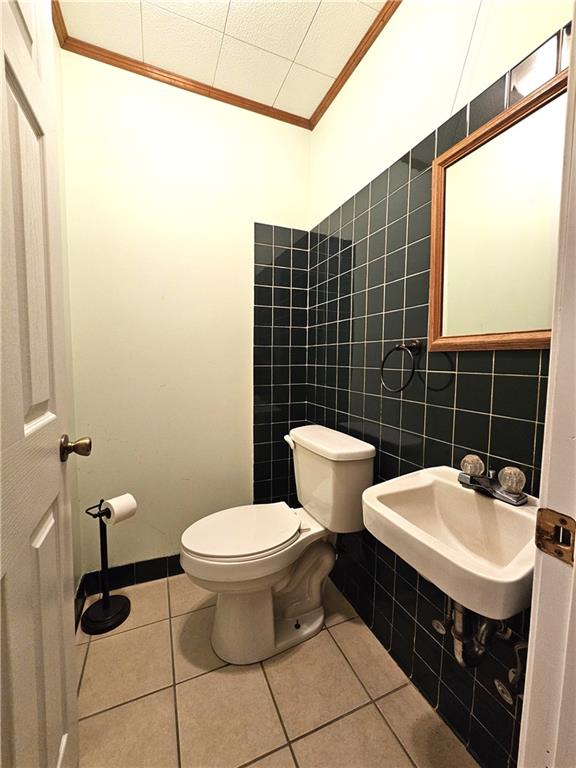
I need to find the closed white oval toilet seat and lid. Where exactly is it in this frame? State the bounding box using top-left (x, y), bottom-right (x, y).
top-left (182, 502), bottom-right (300, 563)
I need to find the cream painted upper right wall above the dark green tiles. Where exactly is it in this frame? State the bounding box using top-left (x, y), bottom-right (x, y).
top-left (309, 0), bottom-right (572, 226)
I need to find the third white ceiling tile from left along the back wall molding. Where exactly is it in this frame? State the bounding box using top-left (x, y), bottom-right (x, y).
top-left (214, 35), bottom-right (290, 105)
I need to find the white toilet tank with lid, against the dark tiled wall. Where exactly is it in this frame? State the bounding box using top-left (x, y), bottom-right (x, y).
top-left (287, 424), bottom-right (376, 533)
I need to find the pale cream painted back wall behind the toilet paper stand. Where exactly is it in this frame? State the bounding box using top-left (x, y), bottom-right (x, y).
top-left (62, 53), bottom-right (309, 570)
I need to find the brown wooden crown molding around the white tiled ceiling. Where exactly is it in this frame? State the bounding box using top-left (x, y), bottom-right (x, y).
top-left (51, 0), bottom-right (402, 131)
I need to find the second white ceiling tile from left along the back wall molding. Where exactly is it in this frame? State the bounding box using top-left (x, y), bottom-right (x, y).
top-left (142, 3), bottom-right (223, 85)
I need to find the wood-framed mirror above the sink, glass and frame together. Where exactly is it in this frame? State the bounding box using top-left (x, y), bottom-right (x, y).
top-left (429, 72), bottom-right (567, 350)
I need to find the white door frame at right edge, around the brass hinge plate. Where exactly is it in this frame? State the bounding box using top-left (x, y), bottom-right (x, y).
top-left (518, 3), bottom-right (576, 768)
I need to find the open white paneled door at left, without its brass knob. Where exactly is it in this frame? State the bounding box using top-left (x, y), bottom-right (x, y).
top-left (0, 0), bottom-right (78, 768)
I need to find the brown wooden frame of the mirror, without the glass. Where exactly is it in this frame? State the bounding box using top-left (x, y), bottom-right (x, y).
top-left (428, 69), bottom-right (568, 351)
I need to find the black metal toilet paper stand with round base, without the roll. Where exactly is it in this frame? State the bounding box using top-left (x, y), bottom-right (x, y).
top-left (80, 499), bottom-right (130, 635)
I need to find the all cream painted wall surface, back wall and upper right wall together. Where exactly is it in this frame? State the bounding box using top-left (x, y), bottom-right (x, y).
top-left (62, 0), bottom-right (571, 570)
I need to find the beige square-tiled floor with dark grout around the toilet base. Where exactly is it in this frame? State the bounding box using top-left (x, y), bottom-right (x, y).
top-left (76, 575), bottom-right (476, 768)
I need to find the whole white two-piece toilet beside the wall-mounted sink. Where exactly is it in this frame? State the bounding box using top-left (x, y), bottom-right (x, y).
top-left (180, 425), bottom-right (375, 664)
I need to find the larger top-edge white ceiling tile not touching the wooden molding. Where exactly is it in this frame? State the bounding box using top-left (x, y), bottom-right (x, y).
top-left (226, 0), bottom-right (318, 59)
